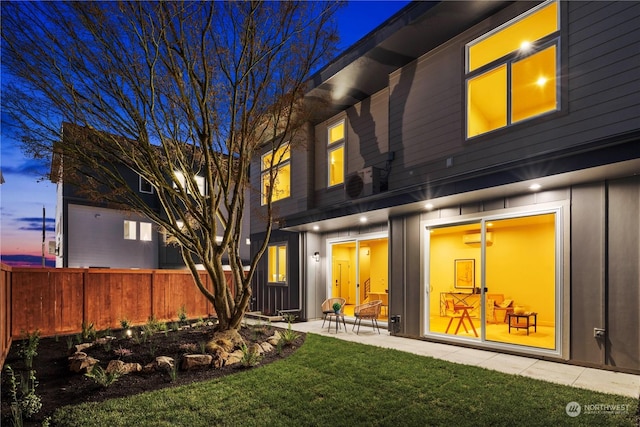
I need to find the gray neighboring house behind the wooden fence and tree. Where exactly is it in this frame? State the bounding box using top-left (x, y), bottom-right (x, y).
top-left (51, 123), bottom-right (250, 269)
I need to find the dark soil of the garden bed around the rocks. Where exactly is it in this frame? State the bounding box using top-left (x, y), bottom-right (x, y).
top-left (0, 325), bottom-right (305, 426)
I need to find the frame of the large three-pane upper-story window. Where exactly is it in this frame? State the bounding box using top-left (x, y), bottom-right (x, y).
top-left (464, 0), bottom-right (564, 141)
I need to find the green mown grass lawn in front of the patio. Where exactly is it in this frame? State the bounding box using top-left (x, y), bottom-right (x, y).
top-left (53, 334), bottom-right (638, 427)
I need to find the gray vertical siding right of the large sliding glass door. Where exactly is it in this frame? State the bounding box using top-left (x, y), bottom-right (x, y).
top-left (571, 176), bottom-right (640, 371)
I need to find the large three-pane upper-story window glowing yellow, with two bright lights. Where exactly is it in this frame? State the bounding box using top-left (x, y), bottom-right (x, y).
top-left (466, 0), bottom-right (560, 138)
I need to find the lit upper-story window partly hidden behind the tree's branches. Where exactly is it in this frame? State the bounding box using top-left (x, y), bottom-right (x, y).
top-left (260, 143), bottom-right (291, 205)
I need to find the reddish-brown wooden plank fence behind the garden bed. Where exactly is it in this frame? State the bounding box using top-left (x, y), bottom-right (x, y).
top-left (0, 264), bottom-right (231, 366)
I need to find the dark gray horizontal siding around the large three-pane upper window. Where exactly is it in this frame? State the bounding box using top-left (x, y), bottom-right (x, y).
top-left (389, 2), bottom-right (640, 189)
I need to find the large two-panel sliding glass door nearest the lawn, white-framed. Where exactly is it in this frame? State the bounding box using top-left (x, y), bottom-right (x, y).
top-left (425, 212), bottom-right (560, 350)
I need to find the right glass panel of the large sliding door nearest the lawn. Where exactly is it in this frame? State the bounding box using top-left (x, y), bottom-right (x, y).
top-left (485, 213), bottom-right (556, 349)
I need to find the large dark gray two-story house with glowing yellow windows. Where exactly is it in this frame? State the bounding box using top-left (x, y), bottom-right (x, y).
top-left (251, 1), bottom-right (640, 373)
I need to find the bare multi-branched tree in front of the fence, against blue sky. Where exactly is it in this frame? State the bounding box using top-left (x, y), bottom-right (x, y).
top-left (2, 1), bottom-right (338, 329)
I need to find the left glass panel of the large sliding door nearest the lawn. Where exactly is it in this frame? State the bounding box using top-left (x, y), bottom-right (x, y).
top-left (428, 222), bottom-right (482, 339)
